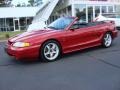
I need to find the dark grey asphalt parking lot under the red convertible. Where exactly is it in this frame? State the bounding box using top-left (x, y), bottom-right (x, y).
top-left (0, 32), bottom-right (120, 90)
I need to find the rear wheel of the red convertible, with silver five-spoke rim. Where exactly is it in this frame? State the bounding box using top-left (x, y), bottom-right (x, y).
top-left (102, 32), bottom-right (113, 48)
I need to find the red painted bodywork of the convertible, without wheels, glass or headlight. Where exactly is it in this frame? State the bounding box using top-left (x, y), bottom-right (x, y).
top-left (6, 18), bottom-right (117, 59)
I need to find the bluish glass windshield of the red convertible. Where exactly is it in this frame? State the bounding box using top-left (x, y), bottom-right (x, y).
top-left (48, 17), bottom-right (74, 30)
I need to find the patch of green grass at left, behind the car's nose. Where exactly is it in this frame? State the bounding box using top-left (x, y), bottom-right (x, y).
top-left (0, 31), bottom-right (25, 40)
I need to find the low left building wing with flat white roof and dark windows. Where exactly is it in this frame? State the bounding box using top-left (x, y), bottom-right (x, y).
top-left (0, 7), bottom-right (39, 31)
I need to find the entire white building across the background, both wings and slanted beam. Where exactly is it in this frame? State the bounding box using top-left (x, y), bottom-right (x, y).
top-left (0, 0), bottom-right (120, 31)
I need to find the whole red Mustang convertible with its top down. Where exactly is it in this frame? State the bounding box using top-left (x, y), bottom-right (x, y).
top-left (5, 17), bottom-right (117, 62)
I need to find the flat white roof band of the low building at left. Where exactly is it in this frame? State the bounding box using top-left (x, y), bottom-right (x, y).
top-left (0, 7), bottom-right (39, 18)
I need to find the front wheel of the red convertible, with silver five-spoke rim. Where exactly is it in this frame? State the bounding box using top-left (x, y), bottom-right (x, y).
top-left (40, 40), bottom-right (61, 62)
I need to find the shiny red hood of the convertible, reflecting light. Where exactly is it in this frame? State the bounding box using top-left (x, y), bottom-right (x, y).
top-left (9, 30), bottom-right (57, 42)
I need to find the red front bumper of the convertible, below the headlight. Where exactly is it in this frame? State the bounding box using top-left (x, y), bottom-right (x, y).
top-left (4, 45), bottom-right (39, 60)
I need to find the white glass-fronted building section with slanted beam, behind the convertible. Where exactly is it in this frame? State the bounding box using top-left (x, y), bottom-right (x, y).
top-left (33, 0), bottom-right (120, 24)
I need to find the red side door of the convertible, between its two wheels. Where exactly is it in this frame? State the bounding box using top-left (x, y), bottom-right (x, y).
top-left (62, 22), bottom-right (94, 52)
